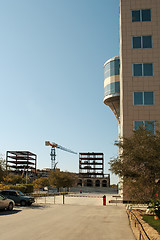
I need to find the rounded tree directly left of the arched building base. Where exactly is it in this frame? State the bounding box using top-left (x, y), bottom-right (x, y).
top-left (49, 171), bottom-right (76, 190)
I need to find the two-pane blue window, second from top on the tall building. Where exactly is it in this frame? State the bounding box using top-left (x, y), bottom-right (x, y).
top-left (132, 36), bottom-right (152, 48)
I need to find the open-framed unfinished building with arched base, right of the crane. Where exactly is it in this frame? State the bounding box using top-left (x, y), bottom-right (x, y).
top-left (78, 152), bottom-right (110, 187)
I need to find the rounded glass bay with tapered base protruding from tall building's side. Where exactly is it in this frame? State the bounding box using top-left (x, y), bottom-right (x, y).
top-left (103, 56), bottom-right (120, 123)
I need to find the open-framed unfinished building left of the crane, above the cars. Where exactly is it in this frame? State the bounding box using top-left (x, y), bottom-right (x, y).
top-left (6, 151), bottom-right (37, 174)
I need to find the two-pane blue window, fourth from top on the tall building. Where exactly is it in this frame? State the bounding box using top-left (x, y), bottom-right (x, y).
top-left (133, 92), bottom-right (154, 105)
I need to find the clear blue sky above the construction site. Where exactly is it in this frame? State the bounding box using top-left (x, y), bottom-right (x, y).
top-left (0, 0), bottom-right (119, 183)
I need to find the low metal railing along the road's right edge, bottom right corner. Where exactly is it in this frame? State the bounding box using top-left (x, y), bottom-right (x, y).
top-left (127, 210), bottom-right (151, 240)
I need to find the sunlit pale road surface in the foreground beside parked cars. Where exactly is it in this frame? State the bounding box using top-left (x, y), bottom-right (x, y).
top-left (0, 200), bottom-right (135, 240)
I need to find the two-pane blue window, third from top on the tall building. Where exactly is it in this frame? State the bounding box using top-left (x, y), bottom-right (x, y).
top-left (133, 63), bottom-right (153, 77)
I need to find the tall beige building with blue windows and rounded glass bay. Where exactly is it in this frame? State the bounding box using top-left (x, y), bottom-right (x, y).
top-left (104, 0), bottom-right (160, 199)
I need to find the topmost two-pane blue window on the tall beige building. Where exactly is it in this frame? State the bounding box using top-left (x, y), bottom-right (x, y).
top-left (131, 9), bottom-right (152, 22)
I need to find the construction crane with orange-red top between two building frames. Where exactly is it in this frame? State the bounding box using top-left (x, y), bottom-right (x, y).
top-left (45, 141), bottom-right (77, 171)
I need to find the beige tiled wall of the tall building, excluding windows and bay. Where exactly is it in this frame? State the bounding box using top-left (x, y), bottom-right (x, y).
top-left (120, 0), bottom-right (160, 137)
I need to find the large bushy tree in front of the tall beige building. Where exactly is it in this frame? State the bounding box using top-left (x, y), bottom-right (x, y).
top-left (109, 127), bottom-right (160, 201)
